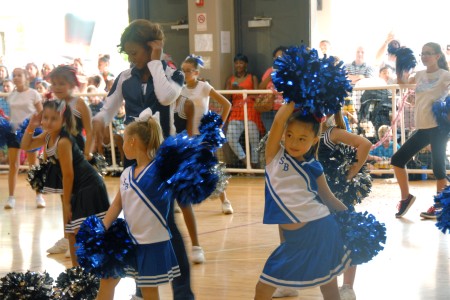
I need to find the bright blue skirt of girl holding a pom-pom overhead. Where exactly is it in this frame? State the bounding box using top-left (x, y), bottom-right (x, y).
top-left (260, 215), bottom-right (351, 289)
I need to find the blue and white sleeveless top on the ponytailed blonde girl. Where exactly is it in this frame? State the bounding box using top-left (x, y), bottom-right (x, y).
top-left (120, 161), bottom-right (171, 244)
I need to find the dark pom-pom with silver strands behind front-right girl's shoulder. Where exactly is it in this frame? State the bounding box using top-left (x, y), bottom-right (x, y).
top-left (321, 144), bottom-right (372, 207)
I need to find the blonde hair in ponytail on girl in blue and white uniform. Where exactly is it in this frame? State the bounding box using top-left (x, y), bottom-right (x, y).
top-left (125, 117), bottom-right (164, 158)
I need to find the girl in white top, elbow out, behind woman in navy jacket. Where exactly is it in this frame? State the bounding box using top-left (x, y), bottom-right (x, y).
top-left (177, 55), bottom-right (233, 263)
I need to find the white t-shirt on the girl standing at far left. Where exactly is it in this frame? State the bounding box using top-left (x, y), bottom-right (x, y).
top-left (7, 88), bottom-right (42, 130)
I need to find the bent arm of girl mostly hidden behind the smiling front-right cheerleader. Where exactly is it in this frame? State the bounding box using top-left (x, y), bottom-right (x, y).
top-left (331, 128), bottom-right (372, 179)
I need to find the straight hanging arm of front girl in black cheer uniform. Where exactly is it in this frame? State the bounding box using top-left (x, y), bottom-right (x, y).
top-left (57, 138), bottom-right (74, 225)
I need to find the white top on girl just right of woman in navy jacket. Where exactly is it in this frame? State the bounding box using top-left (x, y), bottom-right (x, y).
top-left (181, 81), bottom-right (212, 134)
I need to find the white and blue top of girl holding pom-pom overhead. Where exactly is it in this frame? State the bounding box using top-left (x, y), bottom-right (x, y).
top-left (263, 147), bottom-right (330, 224)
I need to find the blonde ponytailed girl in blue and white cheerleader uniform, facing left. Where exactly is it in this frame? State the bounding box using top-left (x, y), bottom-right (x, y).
top-left (97, 111), bottom-right (180, 300)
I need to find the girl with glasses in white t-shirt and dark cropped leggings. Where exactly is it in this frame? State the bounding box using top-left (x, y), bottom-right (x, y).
top-left (391, 42), bottom-right (450, 219)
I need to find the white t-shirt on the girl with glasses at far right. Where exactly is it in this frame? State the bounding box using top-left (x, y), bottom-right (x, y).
top-left (414, 69), bottom-right (450, 129)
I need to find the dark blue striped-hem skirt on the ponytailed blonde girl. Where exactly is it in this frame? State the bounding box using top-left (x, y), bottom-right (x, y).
top-left (126, 240), bottom-right (181, 287)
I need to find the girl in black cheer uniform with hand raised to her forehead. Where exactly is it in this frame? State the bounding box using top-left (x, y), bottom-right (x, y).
top-left (21, 100), bottom-right (109, 266)
